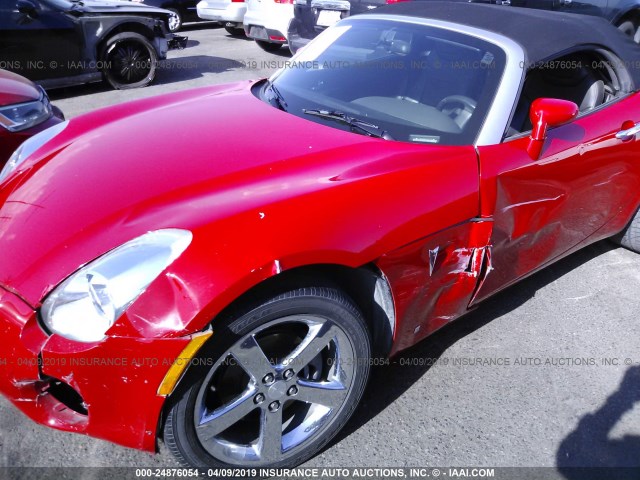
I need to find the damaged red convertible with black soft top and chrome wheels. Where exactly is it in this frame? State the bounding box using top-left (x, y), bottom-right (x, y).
top-left (0, 1), bottom-right (640, 467)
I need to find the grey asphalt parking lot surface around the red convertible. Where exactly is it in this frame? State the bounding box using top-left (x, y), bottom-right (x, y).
top-left (0, 24), bottom-right (640, 467)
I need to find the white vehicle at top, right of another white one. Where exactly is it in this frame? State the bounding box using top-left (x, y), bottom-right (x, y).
top-left (244, 0), bottom-right (293, 52)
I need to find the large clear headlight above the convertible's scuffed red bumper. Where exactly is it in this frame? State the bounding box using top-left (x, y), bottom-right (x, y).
top-left (41, 229), bottom-right (192, 342)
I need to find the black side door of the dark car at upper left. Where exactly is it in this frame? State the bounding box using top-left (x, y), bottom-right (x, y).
top-left (0, 0), bottom-right (84, 81)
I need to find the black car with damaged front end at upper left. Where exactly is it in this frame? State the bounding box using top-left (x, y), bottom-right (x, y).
top-left (0, 0), bottom-right (187, 89)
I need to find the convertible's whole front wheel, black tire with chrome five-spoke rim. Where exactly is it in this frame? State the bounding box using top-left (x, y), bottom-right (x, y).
top-left (164, 288), bottom-right (371, 468)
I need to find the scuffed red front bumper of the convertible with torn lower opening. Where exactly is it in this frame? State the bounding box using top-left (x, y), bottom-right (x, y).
top-left (0, 287), bottom-right (191, 451)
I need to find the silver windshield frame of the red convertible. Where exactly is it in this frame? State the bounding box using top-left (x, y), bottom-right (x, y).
top-left (348, 14), bottom-right (526, 147)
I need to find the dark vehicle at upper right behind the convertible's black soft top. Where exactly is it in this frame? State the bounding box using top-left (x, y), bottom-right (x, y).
top-left (470, 0), bottom-right (640, 43)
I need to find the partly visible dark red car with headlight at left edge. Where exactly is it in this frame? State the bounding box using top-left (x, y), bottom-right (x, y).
top-left (0, 69), bottom-right (64, 168)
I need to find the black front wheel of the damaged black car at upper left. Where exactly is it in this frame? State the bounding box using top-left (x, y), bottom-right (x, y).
top-left (103, 33), bottom-right (158, 90)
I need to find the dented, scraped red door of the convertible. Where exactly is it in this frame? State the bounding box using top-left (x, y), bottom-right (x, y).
top-left (473, 88), bottom-right (640, 303)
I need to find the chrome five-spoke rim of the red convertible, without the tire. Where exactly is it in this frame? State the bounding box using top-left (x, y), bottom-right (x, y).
top-left (194, 315), bottom-right (355, 465)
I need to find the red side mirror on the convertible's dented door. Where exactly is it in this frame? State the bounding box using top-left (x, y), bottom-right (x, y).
top-left (527, 98), bottom-right (579, 160)
